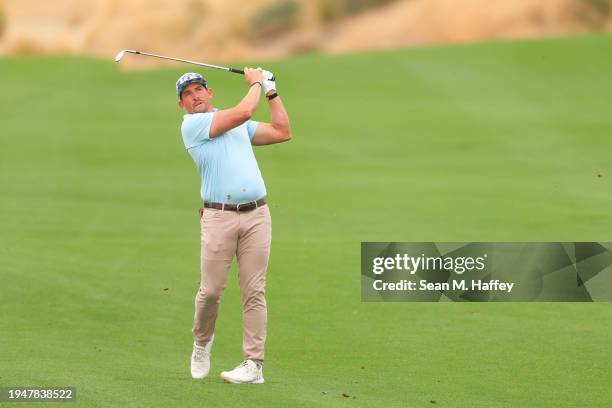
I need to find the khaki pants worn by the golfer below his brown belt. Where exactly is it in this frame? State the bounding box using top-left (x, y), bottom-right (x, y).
top-left (193, 205), bottom-right (272, 361)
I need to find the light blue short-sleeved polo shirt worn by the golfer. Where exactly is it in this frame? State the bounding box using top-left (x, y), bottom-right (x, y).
top-left (181, 109), bottom-right (266, 204)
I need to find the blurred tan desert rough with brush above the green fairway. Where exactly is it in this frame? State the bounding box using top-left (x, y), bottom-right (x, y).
top-left (0, 0), bottom-right (612, 64)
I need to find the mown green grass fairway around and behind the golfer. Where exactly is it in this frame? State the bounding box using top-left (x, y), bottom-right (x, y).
top-left (0, 36), bottom-right (612, 408)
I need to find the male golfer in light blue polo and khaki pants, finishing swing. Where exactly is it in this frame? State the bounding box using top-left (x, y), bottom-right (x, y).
top-left (176, 68), bottom-right (291, 384)
